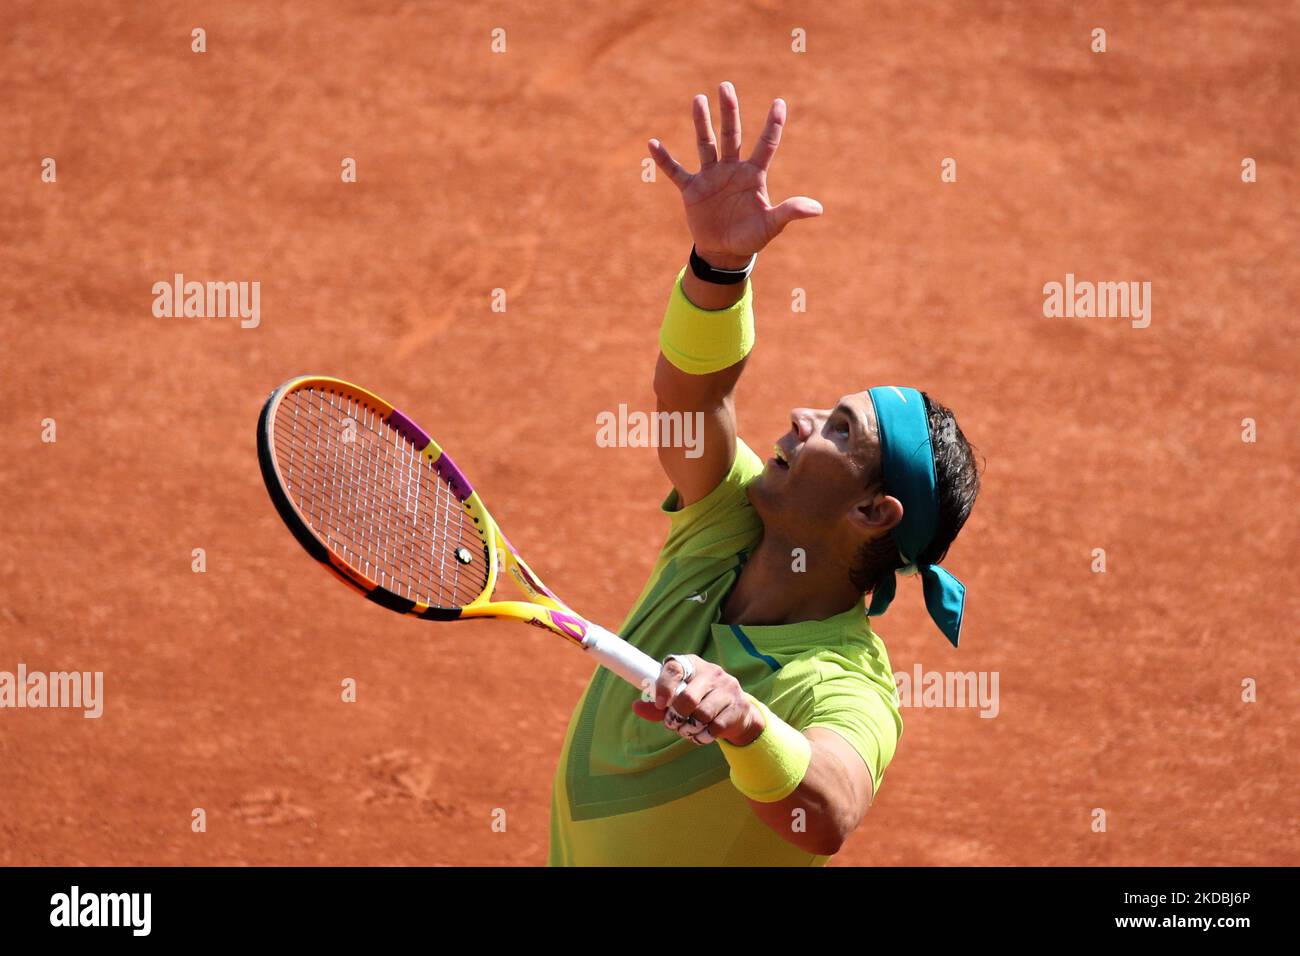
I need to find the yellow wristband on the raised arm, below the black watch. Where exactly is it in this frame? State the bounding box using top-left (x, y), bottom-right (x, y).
top-left (659, 267), bottom-right (754, 375)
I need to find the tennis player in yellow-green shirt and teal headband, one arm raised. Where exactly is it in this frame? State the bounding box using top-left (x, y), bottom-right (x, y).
top-left (550, 83), bottom-right (979, 866)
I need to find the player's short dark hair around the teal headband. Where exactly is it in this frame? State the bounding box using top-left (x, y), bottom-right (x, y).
top-left (849, 392), bottom-right (979, 594)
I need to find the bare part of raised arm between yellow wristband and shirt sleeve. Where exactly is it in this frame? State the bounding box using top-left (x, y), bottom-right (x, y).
top-left (654, 352), bottom-right (745, 507)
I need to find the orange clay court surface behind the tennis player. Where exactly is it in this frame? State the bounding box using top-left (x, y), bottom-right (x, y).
top-left (0, 0), bottom-right (1300, 865)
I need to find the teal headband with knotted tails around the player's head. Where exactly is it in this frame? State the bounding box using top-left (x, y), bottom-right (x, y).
top-left (867, 385), bottom-right (966, 648)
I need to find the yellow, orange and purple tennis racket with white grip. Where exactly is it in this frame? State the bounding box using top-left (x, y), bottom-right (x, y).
top-left (257, 376), bottom-right (659, 688)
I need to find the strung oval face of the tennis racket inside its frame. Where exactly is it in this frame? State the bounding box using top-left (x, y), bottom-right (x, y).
top-left (273, 388), bottom-right (488, 607)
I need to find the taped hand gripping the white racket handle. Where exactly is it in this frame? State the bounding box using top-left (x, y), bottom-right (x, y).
top-left (632, 654), bottom-right (763, 747)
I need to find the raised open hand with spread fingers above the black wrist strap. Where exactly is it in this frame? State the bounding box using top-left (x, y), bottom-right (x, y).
top-left (650, 82), bottom-right (822, 269)
